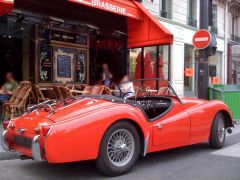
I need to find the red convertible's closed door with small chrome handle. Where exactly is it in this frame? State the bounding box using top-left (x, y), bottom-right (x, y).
top-left (152, 100), bottom-right (191, 150)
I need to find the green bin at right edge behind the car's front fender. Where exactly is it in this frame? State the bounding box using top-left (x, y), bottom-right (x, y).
top-left (209, 84), bottom-right (240, 121)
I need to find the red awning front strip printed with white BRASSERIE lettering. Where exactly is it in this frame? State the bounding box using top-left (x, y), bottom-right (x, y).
top-left (68, 0), bottom-right (142, 19)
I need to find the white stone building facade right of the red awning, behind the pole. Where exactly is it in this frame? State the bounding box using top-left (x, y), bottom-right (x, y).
top-left (143, 0), bottom-right (240, 97)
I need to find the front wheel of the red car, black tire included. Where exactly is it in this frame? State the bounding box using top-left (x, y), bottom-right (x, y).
top-left (209, 112), bottom-right (226, 149)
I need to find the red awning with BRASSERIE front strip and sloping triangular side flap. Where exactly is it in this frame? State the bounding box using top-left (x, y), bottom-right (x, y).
top-left (68, 0), bottom-right (173, 48)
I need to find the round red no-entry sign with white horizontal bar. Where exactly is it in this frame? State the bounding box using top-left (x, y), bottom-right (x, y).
top-left (193, 29), bottom-right (211, 49)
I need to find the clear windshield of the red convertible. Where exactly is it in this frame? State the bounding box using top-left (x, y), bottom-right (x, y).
top-left (113, 78), bottom-right (181, 101)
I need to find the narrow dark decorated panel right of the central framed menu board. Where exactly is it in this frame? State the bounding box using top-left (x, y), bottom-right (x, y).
top-left (75, 50), bottom-right (87, 83)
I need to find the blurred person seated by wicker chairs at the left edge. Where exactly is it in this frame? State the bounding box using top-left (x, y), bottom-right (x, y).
top-left (0, 72), bottom-right (18, 103)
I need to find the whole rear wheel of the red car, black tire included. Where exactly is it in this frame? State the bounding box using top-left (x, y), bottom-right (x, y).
top-left (96, 121), bottom-right (140, 176)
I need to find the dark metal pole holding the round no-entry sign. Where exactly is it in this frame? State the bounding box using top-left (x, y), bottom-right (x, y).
top-left (198, 0), bottom-right (212, 99)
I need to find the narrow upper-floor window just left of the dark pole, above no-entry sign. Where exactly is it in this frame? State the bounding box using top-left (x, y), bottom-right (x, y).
top-left (188, 0), bottom-right (197, 27)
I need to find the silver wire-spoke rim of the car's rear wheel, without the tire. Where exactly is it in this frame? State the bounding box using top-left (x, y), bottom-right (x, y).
top-left (107, 129), bottom-right (135, 167)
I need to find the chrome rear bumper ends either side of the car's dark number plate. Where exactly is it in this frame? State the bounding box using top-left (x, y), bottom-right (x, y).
top-left (1, 130), bottom-right (42, 161)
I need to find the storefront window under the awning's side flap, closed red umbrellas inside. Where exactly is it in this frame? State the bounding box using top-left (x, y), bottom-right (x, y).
top-left (129, 45), bottom-right (169, 88)
